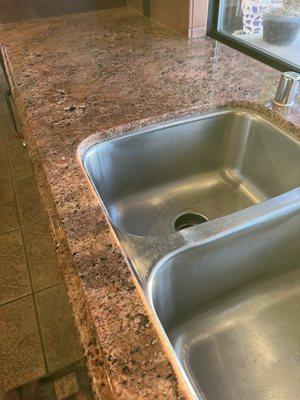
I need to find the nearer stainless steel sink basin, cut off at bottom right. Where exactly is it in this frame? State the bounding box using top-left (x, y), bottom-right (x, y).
top-left (149, 204), bottom-right (300, 400)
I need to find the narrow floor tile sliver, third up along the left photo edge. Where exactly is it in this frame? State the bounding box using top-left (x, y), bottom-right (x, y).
top-left (0, 177), bottom-right (19, 234)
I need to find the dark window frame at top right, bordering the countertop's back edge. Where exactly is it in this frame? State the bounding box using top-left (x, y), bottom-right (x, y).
top-left (206, 0), bottom-right (300, 73)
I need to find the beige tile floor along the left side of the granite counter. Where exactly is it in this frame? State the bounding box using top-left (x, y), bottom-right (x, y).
top-left (0, 89), bottom-right (86, 400)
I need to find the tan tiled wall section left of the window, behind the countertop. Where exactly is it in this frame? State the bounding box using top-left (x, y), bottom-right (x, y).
top-left (128, 0), bottom-right (209, 38)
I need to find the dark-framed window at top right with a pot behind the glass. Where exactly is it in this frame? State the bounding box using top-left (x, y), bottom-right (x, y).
top-left (208, 0), bottom-right (300, 72)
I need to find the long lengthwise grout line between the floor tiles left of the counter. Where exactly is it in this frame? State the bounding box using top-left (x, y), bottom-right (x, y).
top-left (0, 96), bottom-right (49, 375)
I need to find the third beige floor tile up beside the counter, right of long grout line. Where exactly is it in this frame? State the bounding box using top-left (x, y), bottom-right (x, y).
top-left (14, 176), bottom-right (45, 226)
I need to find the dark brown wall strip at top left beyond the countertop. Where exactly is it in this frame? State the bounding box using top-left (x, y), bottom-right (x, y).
top-left (0, 0), bottom-right (126, 23)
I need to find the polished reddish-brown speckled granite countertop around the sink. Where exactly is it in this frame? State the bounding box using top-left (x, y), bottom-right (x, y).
top-left (1, 4), bottom-right (300, 400)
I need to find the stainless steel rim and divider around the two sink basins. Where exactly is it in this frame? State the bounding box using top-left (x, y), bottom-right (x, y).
top-left (78, 107), bottom-right (300, 400)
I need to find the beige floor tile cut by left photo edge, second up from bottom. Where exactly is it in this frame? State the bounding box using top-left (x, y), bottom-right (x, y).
top-left (0, 230), bottom-right (31, 304)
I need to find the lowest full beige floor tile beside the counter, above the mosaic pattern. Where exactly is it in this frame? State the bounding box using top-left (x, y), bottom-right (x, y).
top-left (36, 284), bottom-right (82, 372)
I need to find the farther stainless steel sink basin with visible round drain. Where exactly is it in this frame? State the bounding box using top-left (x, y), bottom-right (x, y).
top-left (84, 110), bottom-right (300, 237)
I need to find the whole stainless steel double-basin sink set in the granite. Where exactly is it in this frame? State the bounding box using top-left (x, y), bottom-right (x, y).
top-left (82, 109), bottom-right (300, 400)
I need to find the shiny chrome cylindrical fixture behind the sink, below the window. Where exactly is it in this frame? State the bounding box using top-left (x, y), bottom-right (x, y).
top-left (274, 71), bottom-right (300, 107)
